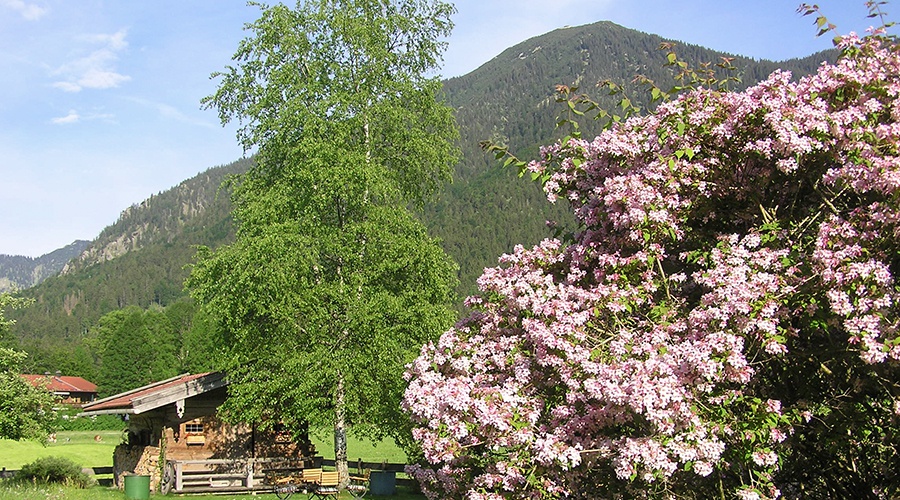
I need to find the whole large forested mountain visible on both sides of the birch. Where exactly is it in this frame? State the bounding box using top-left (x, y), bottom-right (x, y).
top-left (0, 22), bottom-right (835, 375)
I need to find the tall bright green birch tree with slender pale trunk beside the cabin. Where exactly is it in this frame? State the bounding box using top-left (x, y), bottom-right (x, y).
top-left (188, 0), bottom-right (456, 484)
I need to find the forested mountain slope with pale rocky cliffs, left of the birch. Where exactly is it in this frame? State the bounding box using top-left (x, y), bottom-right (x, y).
top-left (0, 160), bottom-right (249, 376)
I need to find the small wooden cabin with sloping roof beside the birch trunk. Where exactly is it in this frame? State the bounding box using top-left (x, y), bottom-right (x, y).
top-left (83, 372), bottom-right (317, 492)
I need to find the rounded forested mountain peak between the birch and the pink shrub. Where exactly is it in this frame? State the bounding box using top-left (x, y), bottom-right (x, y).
top-left (423, 21), bottom-right (835, 292)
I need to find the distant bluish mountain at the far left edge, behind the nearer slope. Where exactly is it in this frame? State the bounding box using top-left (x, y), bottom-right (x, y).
top-left (0, 240), bottom-right (91, 293)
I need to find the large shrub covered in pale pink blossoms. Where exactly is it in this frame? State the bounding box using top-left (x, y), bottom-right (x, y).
top-left (404, 31), bottom-right (900, 499)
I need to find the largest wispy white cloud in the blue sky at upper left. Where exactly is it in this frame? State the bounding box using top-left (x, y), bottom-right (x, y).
top-left (53, 30), bottom-right (131, 92)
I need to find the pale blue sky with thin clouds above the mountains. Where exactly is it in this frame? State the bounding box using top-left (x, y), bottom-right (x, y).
top-left (0, 0), bottom-right (884, 257)
